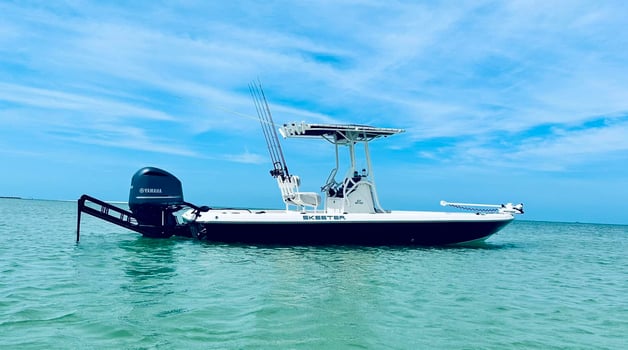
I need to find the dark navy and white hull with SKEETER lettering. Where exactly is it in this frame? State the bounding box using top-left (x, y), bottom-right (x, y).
top-left (182, 209), bottom-right (514, 246)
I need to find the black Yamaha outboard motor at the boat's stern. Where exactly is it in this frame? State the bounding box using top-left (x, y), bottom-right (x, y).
top-left (129, 167), bottom-right (187, 238)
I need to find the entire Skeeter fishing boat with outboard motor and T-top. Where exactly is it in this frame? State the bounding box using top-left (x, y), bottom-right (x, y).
top-left (76, 84), bottom-right (524, 246)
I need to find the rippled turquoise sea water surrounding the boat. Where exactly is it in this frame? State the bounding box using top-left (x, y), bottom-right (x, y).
top-left (0, 199), bottom-right (628, 349)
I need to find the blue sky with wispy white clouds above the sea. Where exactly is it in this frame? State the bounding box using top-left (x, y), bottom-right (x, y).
top-left (0, 0), bottom-right (628, 224)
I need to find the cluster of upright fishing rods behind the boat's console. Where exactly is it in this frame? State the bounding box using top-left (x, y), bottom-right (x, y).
top-left (249, 81), bottom-right (289, 178)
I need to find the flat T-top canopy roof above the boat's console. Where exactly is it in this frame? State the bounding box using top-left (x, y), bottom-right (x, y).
top-left (279, 122), bottom-right (405, 143)
